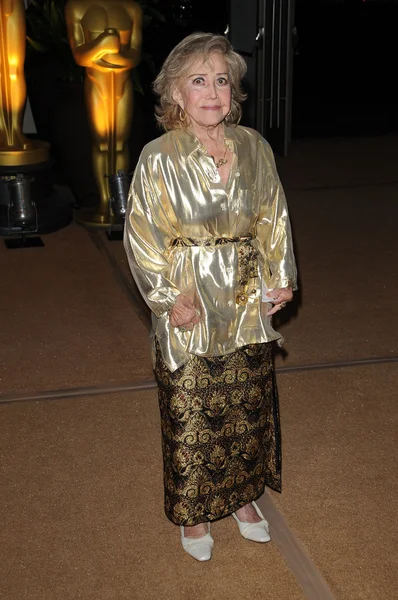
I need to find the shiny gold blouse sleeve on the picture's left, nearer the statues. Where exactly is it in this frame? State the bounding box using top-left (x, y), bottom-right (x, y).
top-left (124, 155), bottom-right (180, 317)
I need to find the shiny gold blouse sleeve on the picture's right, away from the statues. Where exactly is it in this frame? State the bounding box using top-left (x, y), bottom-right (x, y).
top-left (257, 142), bottom-right (297, 290)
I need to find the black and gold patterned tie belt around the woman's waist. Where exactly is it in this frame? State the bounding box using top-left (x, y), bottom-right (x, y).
top-left (170, 233), bottom-right (258, 306)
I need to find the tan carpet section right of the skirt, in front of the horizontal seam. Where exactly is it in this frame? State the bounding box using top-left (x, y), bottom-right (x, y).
top-left (272, 364), bottom-right (398, 600)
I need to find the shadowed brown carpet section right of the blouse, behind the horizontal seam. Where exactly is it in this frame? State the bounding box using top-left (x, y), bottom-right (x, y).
top-left (277, 180), bottom-right (398, 366)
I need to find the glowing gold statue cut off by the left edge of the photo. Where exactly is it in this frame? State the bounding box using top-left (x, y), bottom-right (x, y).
top-left (0, 0), bottom-right (49, 167)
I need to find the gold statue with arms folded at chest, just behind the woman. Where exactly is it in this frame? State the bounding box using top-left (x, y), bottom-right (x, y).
top-left (65, 0), bottom-right (142, 226)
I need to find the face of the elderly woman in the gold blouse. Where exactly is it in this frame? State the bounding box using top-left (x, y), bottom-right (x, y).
top-left (173, 52), bottom-right (231, 127)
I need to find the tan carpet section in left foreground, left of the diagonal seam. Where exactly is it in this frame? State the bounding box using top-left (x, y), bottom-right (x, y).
top-left (0, 392), bottom-right (305, 600)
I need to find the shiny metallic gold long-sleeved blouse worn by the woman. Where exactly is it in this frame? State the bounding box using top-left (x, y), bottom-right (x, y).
top-left (124, 126), bottom-right (297, 371)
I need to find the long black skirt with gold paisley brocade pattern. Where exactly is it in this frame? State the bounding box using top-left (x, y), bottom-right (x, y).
top-left (155, 343), bottom-right (281, 526)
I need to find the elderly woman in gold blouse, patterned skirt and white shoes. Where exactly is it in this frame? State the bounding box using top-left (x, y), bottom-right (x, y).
top-left (125, 33), bottom-right (296, 561)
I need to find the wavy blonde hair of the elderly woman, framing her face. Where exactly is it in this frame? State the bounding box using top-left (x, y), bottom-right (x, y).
top-left (153, 32), bottom-right (247, 131)
